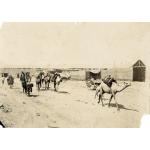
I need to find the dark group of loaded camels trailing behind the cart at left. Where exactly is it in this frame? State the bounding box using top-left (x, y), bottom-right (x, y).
top-left (1, 71), bottom-right (70, 96)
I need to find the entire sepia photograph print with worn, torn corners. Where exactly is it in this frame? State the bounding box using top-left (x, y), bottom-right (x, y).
top-left (0, 22), bottom-right (150, 128)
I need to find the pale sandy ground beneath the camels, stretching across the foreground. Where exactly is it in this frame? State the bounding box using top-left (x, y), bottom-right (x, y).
top-left (0, 79), bottom-right (150, 128)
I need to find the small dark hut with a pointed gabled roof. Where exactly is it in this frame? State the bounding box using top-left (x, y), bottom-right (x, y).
top-left (132, 60), bottom-right (146, 82)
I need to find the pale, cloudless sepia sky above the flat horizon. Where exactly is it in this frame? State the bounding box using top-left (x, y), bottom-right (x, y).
top-left (0, 23), bottom-right (150, 68)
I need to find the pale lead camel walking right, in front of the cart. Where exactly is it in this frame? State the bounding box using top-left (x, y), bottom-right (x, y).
top-left (95, 81), bottom-right (131, 110)
